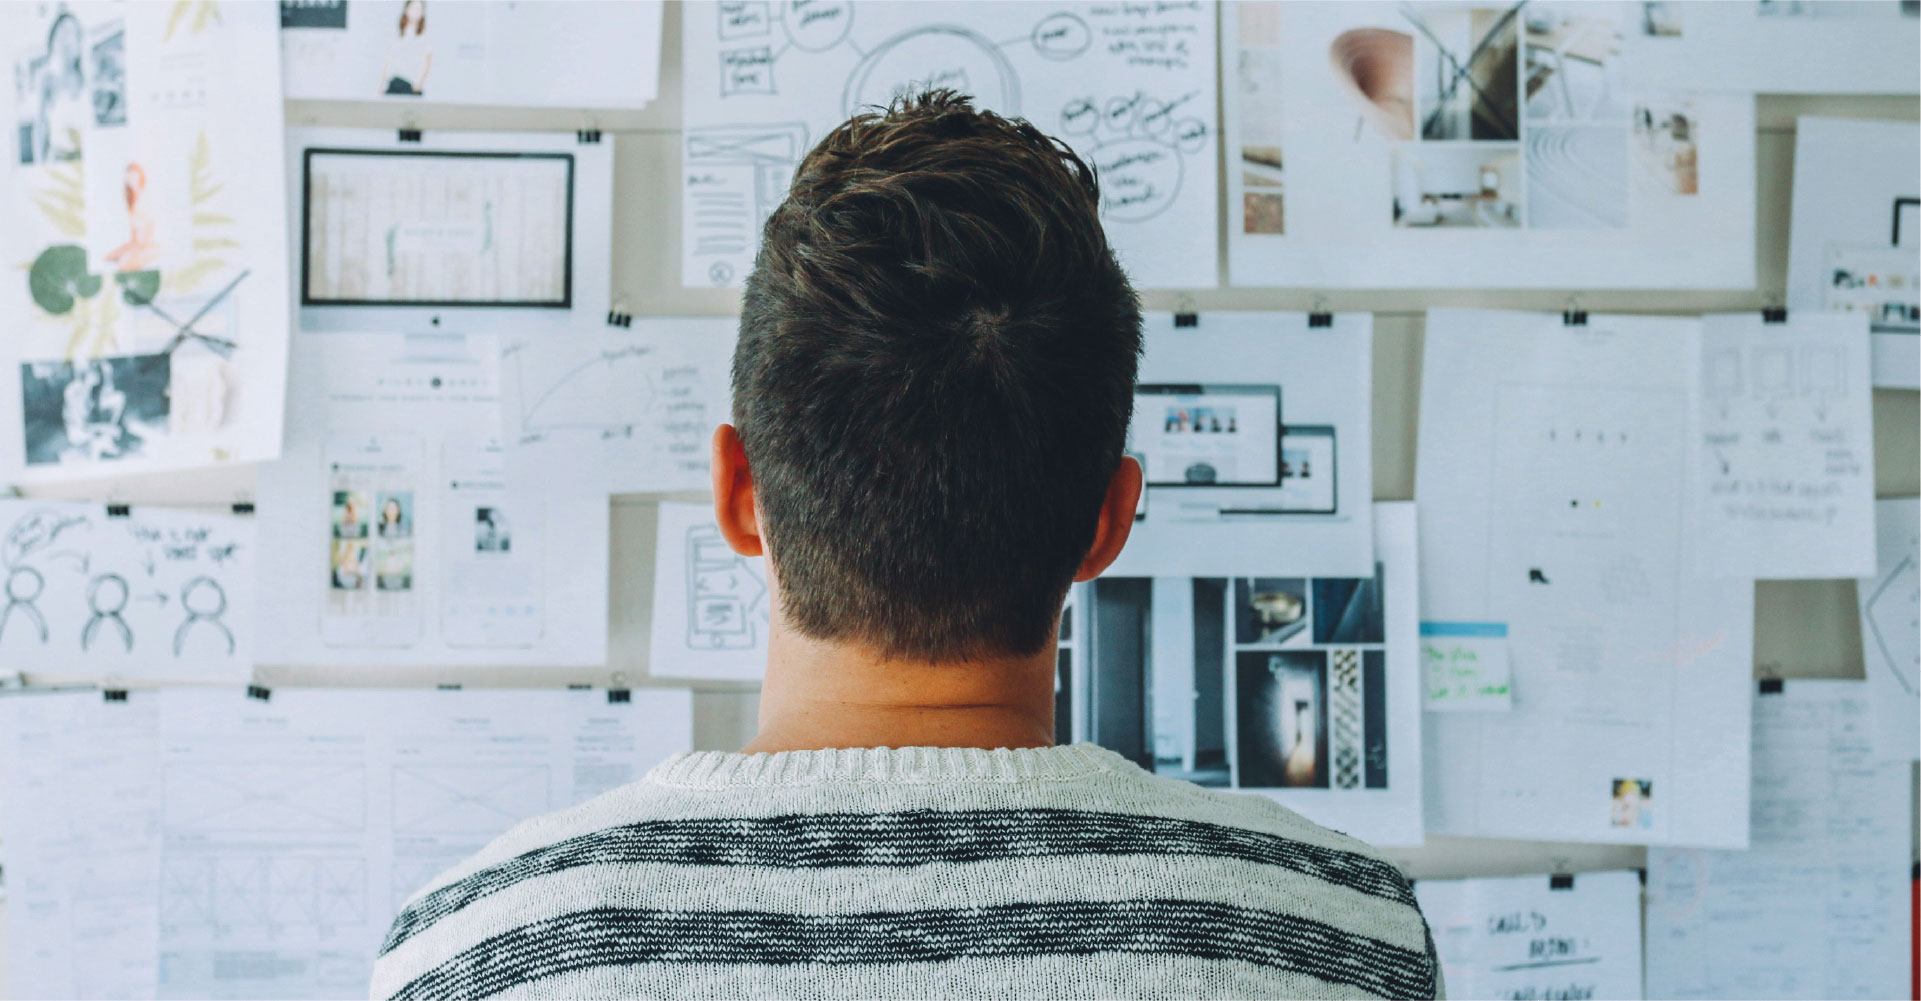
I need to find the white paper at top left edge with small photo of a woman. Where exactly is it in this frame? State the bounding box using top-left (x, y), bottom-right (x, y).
top-left (280, 0), bottom-right (661, 111)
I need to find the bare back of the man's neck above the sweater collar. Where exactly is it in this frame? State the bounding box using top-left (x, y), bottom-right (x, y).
top-left (743, 623), bottom-right (1055, 753)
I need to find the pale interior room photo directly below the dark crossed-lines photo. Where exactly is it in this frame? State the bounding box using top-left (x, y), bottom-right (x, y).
top-left (1393, 142), bottom-right (1521, 229)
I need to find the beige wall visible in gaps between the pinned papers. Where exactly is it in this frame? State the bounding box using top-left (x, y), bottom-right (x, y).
top-left (15, 4), bottom-right (1921, 899)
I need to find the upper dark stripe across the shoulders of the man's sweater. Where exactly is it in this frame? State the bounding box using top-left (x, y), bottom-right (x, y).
top-left (380, 809), bottom-right (1414, 955)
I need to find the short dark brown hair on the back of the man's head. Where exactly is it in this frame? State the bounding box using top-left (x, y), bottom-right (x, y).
top-left (734, 90), bottom-right (1141, 661)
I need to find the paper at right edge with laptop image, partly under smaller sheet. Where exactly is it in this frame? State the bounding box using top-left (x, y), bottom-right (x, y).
top-left (1787, 114), bottom-right (1921, 390)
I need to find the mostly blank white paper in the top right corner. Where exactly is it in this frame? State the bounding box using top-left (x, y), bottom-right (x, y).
top-left (1627, 0), bottom-right (1921, 94)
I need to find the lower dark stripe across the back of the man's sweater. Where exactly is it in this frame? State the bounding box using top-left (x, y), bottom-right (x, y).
top-left (392, 899), bottom-right (1435, 1001)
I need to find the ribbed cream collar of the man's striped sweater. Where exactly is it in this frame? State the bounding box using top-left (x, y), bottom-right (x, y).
top-left (647, 744), bottom-right (1130, 790)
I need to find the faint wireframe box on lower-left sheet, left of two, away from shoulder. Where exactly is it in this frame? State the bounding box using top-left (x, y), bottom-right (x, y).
top-left (161, 761), bottom-right (367, 834)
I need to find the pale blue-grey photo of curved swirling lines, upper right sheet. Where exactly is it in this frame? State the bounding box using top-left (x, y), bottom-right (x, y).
top-left (1527, 125), bottom-right (1627, 229)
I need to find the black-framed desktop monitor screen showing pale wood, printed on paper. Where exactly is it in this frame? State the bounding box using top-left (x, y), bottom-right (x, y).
top-left (300, 148), bottom-right (574, 309)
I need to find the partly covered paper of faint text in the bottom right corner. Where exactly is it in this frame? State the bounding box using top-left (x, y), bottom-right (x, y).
top-left (1648, 678), bottom-right (1915, 999)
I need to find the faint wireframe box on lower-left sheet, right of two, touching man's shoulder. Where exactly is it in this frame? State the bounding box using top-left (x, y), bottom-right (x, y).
top-left (394, 765), bottom-right (553, 838)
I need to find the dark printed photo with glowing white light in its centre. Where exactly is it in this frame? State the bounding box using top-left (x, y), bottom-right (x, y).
top-left (1235, 649), bottom-right (1329, 790)
